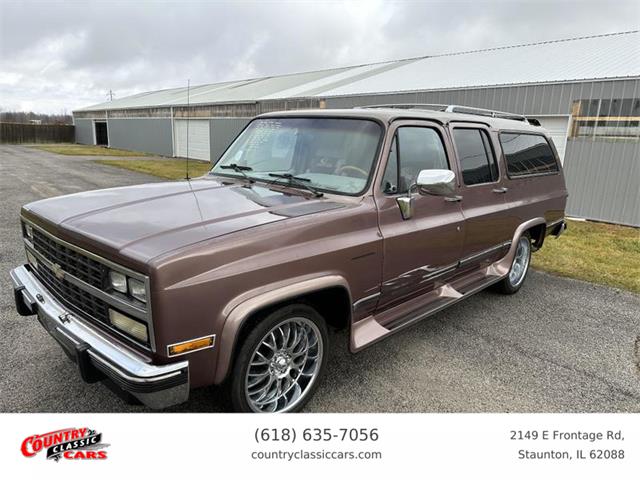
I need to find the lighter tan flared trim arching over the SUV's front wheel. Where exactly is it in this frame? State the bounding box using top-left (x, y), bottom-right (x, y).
top-left (214, 274), bottom-right (352, 384)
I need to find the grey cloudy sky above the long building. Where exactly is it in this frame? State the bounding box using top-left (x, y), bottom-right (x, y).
top-left (0, 0), bottom-right (640, 113)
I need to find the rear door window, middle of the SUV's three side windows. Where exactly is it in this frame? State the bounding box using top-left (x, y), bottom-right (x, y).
top-left (453, 128), bottom-right (498, 185)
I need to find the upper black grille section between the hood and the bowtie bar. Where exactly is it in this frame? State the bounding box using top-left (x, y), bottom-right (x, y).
top-left (33, 228), bottom-right (107, 289)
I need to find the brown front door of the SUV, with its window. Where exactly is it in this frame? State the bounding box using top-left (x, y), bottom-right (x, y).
top-left (375, 121), bottom-right (464, 310)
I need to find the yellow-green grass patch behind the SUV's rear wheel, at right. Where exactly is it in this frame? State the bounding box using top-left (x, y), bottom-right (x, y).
top-left (532, 221), bottom-right (640, 293)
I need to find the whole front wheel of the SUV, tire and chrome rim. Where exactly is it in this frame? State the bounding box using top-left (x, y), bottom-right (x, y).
top-left (228, 304), bottom-right (328, 413)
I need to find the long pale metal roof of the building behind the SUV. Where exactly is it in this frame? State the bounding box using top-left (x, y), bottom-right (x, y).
top-left (77, 30), bottom-right (640, 111)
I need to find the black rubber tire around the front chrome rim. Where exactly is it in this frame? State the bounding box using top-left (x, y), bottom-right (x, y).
top-left (226, 304), bottom-right (329, 412)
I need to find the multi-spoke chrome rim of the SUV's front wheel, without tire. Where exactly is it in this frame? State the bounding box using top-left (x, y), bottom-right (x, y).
top-left (245, 317), bottom-right (323, 412)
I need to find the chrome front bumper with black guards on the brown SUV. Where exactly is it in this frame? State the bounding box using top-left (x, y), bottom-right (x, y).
top-left (10, 265), bottom-right (189, 408)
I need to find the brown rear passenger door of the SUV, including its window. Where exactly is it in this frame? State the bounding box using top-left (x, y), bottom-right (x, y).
top-left (450, 122), bottom-right (513, 270)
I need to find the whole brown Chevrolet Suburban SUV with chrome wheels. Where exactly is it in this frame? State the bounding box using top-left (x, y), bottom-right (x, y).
top-left (11, 105), bottom-right (567, 412)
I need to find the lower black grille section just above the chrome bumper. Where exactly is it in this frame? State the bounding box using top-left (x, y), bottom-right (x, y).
top-left (34, 258), bottom-right (109, 326)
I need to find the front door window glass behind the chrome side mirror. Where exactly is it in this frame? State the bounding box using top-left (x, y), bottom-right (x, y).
top-left (382, 127), bottom-right (449, 194)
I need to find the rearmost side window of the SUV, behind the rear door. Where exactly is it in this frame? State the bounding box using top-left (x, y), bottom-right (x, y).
top-left (500, 133), bottom-right (558, 177)
